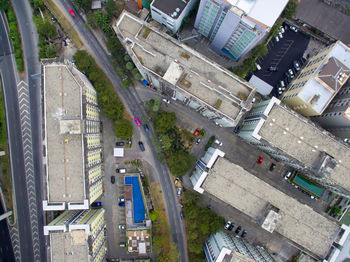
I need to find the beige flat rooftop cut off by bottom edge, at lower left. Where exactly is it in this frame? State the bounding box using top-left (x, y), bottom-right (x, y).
top-left (50, 230), bottom-right (90, 262)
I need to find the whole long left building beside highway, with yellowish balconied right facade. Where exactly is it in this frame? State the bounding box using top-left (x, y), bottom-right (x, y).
top-left (42, 60), bottom-right (103, 211)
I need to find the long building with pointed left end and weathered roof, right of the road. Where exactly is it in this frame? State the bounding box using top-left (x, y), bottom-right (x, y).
top-left (113, 11), bottom-right (255, 127)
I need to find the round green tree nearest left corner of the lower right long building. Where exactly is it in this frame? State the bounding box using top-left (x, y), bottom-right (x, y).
top-left (168, 151), bottom-right (196, 177)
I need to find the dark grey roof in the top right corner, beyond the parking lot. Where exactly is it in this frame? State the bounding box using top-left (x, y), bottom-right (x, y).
top-left (295, 0), bottom-right (350, 44)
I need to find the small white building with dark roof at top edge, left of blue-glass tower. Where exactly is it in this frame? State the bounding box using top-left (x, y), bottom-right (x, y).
top-left (151, 0), bottom-right (198, 33)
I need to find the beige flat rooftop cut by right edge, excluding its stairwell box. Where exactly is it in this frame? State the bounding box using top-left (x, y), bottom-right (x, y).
top-left (258, 104), bottom-right (350, 191)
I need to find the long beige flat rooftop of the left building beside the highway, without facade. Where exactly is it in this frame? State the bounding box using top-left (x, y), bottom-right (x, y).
top-left (43, 63), bottom-right (86, 202)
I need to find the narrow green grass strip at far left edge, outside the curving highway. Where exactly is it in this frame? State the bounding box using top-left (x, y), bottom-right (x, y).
top-left (0, 82), bottom-right (13, 210)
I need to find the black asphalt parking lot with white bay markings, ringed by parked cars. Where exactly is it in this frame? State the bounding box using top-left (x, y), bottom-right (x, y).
top-left (254, 25), bottom-right (310, 95)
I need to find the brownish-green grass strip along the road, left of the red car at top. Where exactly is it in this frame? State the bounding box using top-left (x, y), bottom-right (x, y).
top-left (44, 0), bottom-right (84, 49)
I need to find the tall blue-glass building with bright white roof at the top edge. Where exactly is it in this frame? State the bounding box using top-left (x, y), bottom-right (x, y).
top-left (194, 0), bottom-right (288, 61)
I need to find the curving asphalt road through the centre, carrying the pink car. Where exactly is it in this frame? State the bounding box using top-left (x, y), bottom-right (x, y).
top-left (56, 0), bottom-right (188, 261)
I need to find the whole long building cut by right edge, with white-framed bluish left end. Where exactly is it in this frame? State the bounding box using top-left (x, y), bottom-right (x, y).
top-left (239, 97), bottom-right (350, 197)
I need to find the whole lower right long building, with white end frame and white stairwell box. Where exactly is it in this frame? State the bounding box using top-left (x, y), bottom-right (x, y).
top-left (191, 148), bottom-right (340, 259)
